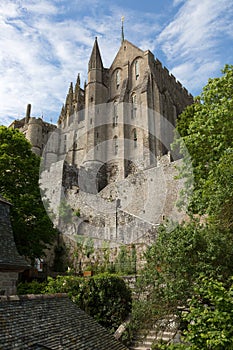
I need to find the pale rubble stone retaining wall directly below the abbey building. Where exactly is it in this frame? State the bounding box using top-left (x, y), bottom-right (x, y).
top-left (42, 155), bottom-right (184, 246)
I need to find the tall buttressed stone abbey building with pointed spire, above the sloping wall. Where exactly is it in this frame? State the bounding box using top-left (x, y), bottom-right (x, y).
top-left (52, 38), bottom-right (193, 192)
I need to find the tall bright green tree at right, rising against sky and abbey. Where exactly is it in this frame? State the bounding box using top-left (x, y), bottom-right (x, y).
top-left (175, 65), bottom-right (233, 229)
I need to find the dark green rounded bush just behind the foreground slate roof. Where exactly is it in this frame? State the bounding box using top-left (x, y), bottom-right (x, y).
top-left (46, 273), bottom-right (132, 332)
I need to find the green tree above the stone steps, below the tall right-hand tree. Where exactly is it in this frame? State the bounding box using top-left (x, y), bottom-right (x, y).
top-left (132, 221), bottom-right (233, 334)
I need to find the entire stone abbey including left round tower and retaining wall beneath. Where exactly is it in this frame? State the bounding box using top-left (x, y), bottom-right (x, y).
top-left (12, 38), bottom-right (193, 243)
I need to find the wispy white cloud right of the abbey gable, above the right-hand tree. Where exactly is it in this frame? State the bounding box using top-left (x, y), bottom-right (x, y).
top-left (157, 0), bottom-right (233, 91)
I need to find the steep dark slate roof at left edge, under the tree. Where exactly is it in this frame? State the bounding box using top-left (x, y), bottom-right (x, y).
top-left (0, 196), bottom-right (30, 271)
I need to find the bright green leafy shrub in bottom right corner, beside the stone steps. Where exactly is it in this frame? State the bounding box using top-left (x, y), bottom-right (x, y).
top-left (155, 277), bottom-right (233, 350)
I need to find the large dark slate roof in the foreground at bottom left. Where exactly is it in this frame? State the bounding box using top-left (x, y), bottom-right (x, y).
top-left (0, 294), bottom-right (127, 350)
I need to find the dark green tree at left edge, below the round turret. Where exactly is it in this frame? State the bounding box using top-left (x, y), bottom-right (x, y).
top-left (0, 126), bottom-right (56, 261)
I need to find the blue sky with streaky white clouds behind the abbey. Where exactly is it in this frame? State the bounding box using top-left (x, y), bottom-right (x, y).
top-left (0, 0), bottom-right (233, 125)
